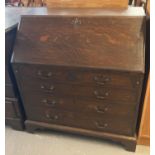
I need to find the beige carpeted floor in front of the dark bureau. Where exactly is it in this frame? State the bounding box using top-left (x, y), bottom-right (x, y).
top-left (6, 127), bottom-right (150, 155)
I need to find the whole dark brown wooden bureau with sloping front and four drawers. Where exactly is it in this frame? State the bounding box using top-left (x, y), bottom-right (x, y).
top-left (12, 7), bottom-right (145, 151)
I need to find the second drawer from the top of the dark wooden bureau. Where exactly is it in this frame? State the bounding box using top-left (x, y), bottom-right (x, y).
top-left (22, 81), bottom-right (137, 104)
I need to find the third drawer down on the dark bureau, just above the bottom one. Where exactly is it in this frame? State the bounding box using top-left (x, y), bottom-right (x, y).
top-left (23, 92), bottom-right (136, 117)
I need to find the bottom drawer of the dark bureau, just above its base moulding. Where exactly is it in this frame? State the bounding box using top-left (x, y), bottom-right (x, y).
top-left (26, 108), bottom-right (133, 135)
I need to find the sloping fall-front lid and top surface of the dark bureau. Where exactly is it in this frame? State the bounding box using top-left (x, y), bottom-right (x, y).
top-left (12, 8), bottom-right (144, 72)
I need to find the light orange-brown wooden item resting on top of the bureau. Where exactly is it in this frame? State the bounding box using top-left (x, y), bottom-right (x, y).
top-left (46, 0), bottom-right (128, 9)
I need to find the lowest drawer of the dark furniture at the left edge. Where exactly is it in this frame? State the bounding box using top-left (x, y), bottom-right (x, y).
top-left (5, 98), bottom-right (21, 118)
